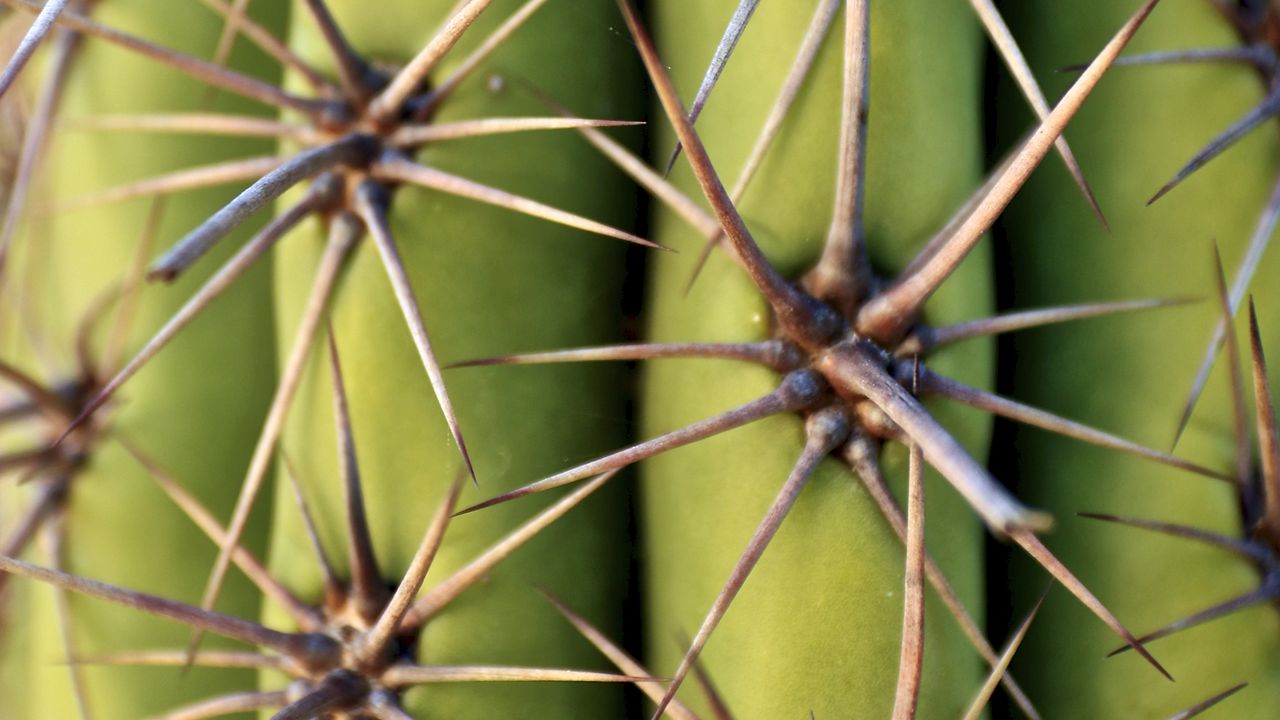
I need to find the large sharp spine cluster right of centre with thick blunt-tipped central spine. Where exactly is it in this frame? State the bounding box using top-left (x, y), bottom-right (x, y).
top-left (450, 3), bottom-right (1187, 715)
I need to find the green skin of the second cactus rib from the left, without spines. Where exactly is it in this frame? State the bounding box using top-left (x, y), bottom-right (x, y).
top-left (261, 0), bottom-right (639, 719)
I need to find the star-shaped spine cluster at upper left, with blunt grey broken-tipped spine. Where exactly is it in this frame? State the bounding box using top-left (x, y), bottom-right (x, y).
top-left (0, 0), bottom-right (653, 666)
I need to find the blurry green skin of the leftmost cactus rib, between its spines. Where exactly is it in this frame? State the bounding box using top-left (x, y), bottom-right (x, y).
top-left (3, 0), bottom-right (284, 719)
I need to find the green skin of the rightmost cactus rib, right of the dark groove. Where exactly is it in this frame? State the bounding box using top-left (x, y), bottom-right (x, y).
top-left (1006, 3), bottom-right (1280, 717)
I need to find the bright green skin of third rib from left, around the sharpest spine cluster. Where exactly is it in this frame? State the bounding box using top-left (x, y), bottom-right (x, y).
top-left (641, 1), bottom-right (992, 717)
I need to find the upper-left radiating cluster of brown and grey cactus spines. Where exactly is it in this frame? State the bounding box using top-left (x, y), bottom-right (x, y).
top-left (0, 0), bottom-right (652, 712)
